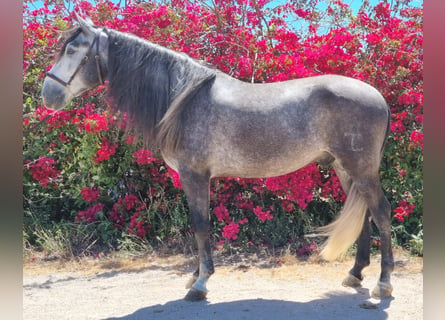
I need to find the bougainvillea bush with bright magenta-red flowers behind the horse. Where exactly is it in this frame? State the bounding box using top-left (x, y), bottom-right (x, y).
top-left (23, 0), bottom-right (423, 255)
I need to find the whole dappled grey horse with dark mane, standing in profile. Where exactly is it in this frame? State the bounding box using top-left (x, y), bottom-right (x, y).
top-left (42, 17), bottom-right (394, 301)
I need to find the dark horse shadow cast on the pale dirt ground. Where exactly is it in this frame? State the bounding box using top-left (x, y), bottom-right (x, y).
top-left (105, 292), bottom-right (392, 320)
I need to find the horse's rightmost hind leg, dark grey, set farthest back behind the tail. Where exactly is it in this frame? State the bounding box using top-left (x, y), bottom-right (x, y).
top-left (355, 175), bottom-right (394, 298)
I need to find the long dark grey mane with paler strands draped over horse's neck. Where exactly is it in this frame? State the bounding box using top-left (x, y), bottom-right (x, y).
top-left (106, 29), bottom-right (216, 155)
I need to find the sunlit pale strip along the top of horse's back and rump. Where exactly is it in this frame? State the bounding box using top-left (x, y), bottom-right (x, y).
top-left (210, 73), bottom-right (386, 113)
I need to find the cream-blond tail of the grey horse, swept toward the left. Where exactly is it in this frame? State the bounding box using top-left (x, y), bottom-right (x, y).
top-left (318, 183), bottom-right (367, 261)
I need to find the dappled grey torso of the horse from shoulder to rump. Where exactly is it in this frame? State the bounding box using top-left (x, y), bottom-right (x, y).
top-left (175, 74), bottom-right (388, 177)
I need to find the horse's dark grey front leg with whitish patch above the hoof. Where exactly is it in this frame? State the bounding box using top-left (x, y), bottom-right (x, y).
top-left (179, 168), bottom-right (214, 301)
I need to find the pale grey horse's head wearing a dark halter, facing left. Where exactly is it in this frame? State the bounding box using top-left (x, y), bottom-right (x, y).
top-left (42, 16), bottom-right (108, 109)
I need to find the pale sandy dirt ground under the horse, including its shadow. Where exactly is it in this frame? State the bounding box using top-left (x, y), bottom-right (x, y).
top-left (23, 251), bottom-right (423, 320)
